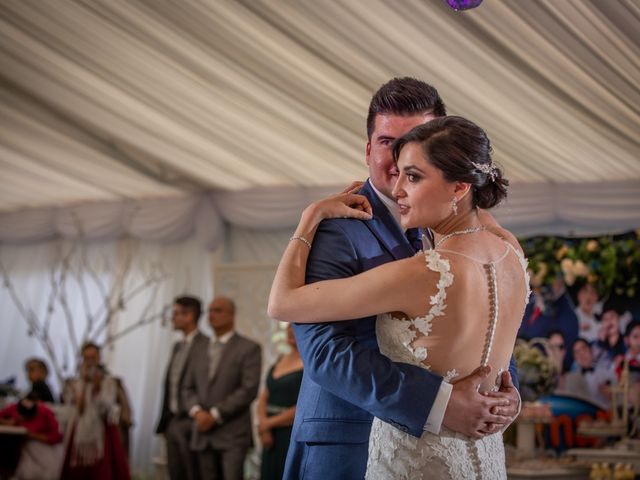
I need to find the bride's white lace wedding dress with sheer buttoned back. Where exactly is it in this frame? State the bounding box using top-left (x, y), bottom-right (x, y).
top-left (366, 234), bottom-right (529, 480)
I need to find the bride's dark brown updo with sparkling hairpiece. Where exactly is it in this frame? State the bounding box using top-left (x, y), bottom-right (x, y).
top-left (393, 116), bottom-right (509, 208)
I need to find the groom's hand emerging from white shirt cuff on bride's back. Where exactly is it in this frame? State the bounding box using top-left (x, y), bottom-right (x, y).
top-left (442, 366), bottom-right (513, 438)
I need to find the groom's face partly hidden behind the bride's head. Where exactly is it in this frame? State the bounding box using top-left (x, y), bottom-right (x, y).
top-left (365, 113), bottom-right (435, 198)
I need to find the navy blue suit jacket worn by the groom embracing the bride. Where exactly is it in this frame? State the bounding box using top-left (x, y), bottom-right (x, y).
top-left (284, 182), bottom-right (520, 480)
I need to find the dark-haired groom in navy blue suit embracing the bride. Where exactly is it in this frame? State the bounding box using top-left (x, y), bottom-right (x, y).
top-left (284, 78), bottom-right (519, 480)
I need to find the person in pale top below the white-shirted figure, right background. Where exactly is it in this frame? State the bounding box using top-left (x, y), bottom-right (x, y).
top-left (558, 338), bottom-right (616, 410)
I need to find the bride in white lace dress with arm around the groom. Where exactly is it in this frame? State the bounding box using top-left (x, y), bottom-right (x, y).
top-left (269, 117), bottom-right (529, 479)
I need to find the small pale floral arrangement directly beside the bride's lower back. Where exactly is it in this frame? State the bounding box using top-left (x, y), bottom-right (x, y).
top-left (513, 338), bottom-right (558, 402)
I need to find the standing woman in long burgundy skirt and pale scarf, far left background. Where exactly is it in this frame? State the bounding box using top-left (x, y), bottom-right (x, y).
top-left (62, 343), bottom-right (130, 480)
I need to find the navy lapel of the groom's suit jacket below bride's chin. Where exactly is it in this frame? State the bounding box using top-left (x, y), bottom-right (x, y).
top-left (359, 180), bottom-right (415, 260)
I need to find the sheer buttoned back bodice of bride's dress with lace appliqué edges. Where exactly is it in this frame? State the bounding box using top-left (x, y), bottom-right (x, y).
top-left (376, 232), bottom-right (529, 391)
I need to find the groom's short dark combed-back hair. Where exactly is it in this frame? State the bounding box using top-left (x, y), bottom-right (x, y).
top-left (367, 77), bottom-right (447, 140)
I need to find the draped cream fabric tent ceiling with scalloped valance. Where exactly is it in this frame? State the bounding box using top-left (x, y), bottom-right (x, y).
top-left (0, 0), bottom-right (640, 244)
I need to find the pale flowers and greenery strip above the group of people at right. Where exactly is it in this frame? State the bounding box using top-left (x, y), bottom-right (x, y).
top-left (521, 230), bottom-right (640, 298)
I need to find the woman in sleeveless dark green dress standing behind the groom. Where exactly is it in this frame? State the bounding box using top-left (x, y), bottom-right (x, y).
top-left (258, 325), bottom-right (302, 480)
